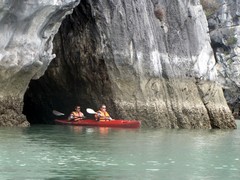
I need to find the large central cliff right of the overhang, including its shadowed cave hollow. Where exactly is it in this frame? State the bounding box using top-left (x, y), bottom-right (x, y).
top-left (25, 0), bottom-right (236, 129)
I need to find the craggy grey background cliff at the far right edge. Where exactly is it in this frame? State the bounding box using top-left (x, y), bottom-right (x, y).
top-left (204, 0), bottom-right (240, 114)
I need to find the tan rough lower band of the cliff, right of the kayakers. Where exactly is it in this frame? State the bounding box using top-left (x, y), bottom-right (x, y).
top-left (112, 79), bottom-right (236, 129)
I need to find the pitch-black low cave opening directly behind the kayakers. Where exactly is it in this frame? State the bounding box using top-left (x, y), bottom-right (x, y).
top-left (23, 77), bottom-right (96, 124)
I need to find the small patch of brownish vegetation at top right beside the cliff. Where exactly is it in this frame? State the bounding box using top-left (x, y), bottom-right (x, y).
top-left (200, 0), bottom-right (220, 17)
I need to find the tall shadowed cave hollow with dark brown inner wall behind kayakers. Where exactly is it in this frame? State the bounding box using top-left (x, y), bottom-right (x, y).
top-left (23, 0), bottom-right (112, 124)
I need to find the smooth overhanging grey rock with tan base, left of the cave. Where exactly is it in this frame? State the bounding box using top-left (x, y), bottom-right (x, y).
top-left (0, 0), bottom-right (79, 126)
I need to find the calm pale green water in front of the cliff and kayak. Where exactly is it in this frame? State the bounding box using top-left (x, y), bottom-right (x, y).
top-left (0, 123), bottom-right (240, 180)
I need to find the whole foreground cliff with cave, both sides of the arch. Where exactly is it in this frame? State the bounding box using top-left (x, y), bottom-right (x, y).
top-left (0, 0), bottom-right (236, 129)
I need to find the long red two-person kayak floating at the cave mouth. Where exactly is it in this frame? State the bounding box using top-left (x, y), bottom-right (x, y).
top-left (55, 119), bottom-right (141, 128)
